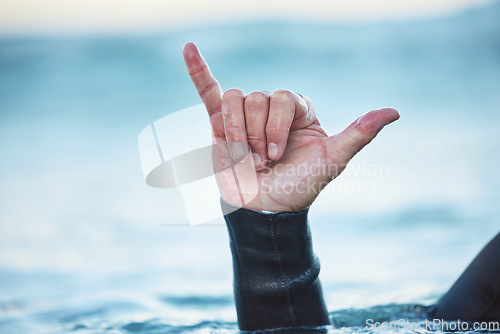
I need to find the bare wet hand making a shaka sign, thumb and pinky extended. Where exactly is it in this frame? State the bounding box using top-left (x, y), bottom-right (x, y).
top-left (184, 43), bottom-right (399, 212)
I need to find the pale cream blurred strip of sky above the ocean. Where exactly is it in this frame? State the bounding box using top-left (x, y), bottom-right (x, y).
top-left (0, 0), bottom-right (489, 34)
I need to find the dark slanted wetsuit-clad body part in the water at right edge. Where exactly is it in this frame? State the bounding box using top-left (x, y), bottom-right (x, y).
top-left (429, 233), bottom-right (500, 321)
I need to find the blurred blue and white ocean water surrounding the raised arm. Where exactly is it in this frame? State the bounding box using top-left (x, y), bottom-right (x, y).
top-left (0, 1), bottom-right (500, 333)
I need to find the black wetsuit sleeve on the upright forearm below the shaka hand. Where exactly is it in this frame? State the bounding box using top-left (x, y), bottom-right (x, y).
top-left (222, 201), bottom-right (330, 333)
